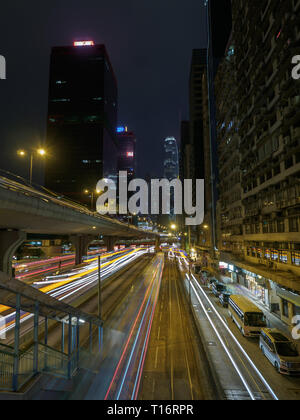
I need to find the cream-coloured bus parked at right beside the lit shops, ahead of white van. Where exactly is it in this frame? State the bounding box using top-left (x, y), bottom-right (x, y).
top-left (228, 295), bottom-right (267, 337)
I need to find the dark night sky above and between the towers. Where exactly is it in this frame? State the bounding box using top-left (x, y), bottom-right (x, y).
top-left (0, 0), bottom-right (206, 181)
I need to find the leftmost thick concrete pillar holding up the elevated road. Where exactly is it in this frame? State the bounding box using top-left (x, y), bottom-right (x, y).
top-left (0, 230), bottom-right (27, 277)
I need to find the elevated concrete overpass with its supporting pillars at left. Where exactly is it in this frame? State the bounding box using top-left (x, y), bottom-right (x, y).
top-left (0, 176), bottom-right (159, 275)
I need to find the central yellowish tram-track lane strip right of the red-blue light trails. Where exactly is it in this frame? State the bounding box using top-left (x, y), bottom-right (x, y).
top-left (138, 257), bottom-right (218, 400)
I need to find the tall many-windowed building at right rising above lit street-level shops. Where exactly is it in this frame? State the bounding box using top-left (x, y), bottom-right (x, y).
top-left (216, 0), bottom-right (300, 325)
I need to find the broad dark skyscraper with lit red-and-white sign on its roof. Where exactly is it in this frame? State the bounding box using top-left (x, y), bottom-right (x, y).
top-left (46, 41), bottom-right (117, 205)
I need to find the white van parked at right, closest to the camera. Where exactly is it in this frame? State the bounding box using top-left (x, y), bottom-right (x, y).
top-left (259, 328), bottom-right (300, 376)
